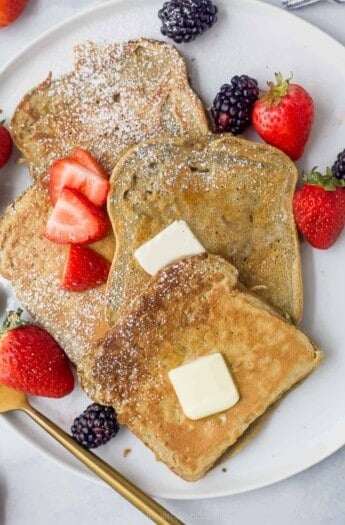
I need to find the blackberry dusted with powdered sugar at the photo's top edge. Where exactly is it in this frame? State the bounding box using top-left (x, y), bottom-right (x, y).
top-left (158, 0), bottom-right (218, 44)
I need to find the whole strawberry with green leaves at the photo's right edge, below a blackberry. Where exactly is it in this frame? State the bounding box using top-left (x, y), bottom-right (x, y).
top-left (293, 168), bottom-right (345, 249)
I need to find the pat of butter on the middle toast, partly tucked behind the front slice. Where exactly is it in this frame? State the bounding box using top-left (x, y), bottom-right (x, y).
top-left (134, 221), bottom-right (205, 275)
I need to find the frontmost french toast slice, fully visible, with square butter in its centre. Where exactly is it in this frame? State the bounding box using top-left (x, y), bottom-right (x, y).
top-left (79, 254), bottom-right (323, 481)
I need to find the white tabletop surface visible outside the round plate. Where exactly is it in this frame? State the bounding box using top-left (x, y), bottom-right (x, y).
top-left (0, 0), bottom-right (345, 525)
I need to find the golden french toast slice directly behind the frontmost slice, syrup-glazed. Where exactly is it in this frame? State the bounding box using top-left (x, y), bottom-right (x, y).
top-left (107, 134), bottom-right (303, 324)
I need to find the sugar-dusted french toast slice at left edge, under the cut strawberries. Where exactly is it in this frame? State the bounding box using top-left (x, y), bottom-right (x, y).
top-left (0, 180), bottom-right (114, 364)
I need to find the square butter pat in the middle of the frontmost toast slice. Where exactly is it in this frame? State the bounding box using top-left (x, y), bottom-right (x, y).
top-left (168, 353), bottom-right (240, 419)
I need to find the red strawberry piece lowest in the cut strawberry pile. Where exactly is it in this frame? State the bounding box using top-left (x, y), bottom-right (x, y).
top-left (60, 244), bottom-right (110, 292)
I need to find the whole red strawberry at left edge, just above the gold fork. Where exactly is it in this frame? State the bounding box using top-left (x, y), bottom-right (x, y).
top-left (0, 309), bottom-right (74, 397)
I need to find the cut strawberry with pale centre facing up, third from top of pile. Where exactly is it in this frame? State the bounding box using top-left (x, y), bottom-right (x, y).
top-left (43, 188), bottom-right (110, 244)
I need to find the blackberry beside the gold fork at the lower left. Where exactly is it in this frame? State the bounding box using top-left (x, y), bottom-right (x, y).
top-left (71, 403), bottom-right (120, 448)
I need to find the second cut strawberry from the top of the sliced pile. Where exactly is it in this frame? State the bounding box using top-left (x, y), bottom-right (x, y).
top-left (49, 159), bottom-right (110, 206)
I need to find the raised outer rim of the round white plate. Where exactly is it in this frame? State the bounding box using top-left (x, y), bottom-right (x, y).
top-left (0, 0), bottom-right (345, 500)
